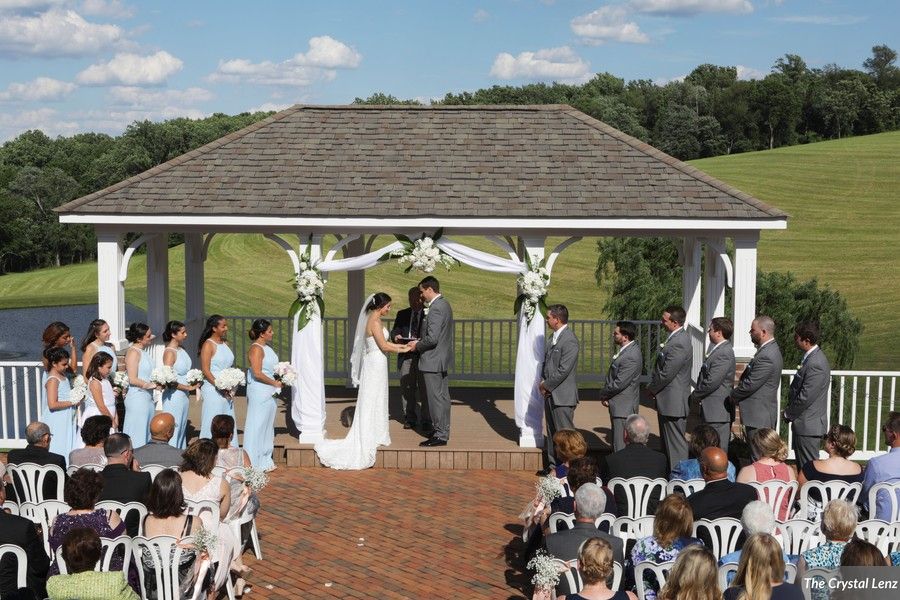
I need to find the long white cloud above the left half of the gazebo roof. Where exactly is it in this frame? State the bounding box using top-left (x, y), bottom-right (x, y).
top-left (208, 35), bottom-right (362, 87)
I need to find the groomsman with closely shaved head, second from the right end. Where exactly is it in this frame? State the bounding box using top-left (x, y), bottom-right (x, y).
top-left (731, 315), bottom-right (784, 440)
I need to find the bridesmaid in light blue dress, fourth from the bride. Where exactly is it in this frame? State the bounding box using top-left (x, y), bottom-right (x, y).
top-left (122, 323), bottom-right (156, 448)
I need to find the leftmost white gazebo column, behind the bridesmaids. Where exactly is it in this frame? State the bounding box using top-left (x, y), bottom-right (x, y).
top-left (96, 227), bottom-right (127, 350)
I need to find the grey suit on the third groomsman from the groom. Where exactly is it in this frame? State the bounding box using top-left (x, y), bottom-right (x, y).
top-left (649, 328), bottom-right (694, 470)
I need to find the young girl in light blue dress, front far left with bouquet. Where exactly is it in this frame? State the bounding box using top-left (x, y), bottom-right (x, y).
top-left (41, 347), bottom-right (80, 456)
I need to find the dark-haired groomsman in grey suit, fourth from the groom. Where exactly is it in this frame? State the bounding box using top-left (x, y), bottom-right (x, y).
top-left (690, 317), bottom-right (735, 454)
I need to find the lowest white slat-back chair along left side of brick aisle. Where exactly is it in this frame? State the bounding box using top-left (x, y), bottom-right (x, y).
top-left (131, 535), bottom-right (209, 600)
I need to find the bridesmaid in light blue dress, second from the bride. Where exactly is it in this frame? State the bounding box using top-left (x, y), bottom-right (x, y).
top-left (197, 315), bottom-right (237, 446)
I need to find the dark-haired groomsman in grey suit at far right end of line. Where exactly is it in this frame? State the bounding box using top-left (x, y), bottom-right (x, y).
top-left (784, 323), bottom-right (831, 471)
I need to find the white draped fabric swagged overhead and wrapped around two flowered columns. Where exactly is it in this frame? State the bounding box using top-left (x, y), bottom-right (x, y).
top-left (291, 238), bottom-right (544, 443)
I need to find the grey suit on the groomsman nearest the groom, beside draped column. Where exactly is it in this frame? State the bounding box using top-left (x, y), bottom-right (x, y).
top-left (541, 327), bottom-right (578, 467)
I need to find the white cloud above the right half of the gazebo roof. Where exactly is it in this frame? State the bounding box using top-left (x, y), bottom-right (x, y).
top-left (491, 46), bottom-right (591, 83)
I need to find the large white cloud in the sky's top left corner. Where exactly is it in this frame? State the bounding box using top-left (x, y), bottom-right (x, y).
top-left (0, 9), bottom-right (124, 56)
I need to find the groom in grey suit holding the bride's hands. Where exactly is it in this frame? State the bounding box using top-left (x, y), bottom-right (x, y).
top-left (410, 275), bottom-right (453, 446)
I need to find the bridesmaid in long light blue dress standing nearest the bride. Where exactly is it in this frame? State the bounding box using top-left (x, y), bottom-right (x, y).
top-left (244, 319), bottom-right (281, 471)
